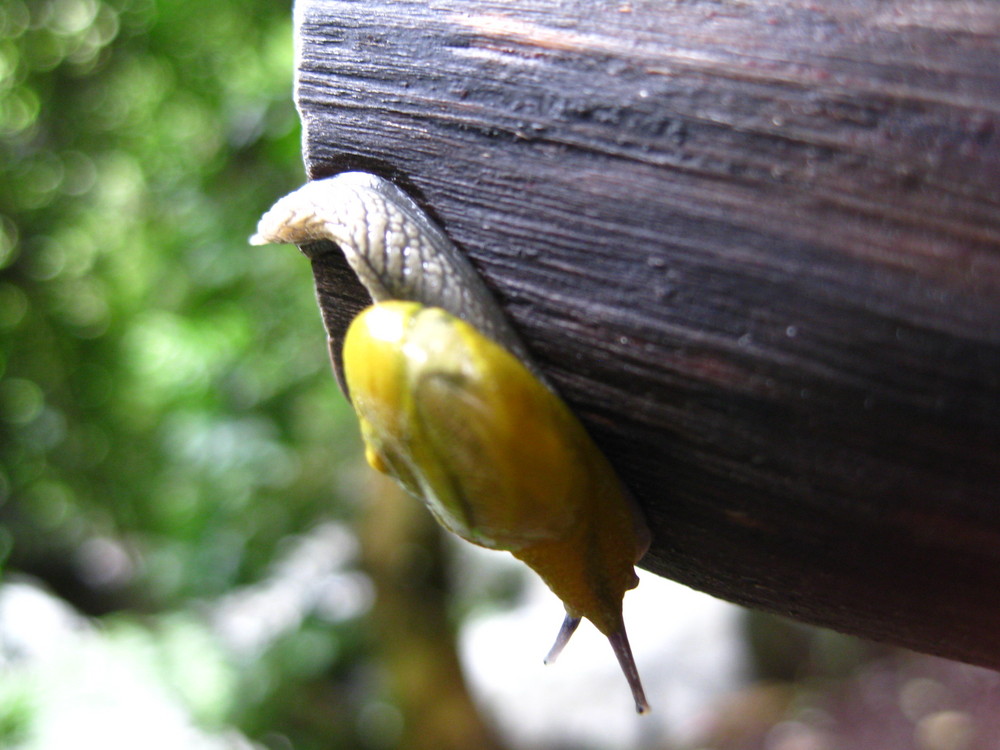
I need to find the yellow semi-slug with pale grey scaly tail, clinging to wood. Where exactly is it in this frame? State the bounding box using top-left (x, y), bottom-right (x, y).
top-left (250, 172), bottom-right (649, 713)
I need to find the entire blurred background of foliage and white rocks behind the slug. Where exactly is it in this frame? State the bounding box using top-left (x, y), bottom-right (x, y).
top-left (0, 0), bottom-right (1000, 750)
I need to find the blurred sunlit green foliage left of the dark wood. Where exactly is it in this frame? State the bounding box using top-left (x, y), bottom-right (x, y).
top-left (0, 0), bottom-right (376, 747)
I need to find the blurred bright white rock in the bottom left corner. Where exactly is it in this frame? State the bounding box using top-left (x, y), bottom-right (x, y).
top-left (0, 581), bottom-right (258, 750)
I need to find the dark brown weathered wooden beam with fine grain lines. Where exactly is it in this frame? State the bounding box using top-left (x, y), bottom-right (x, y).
top-left (297, 0), bottom-right (1000, 667)
